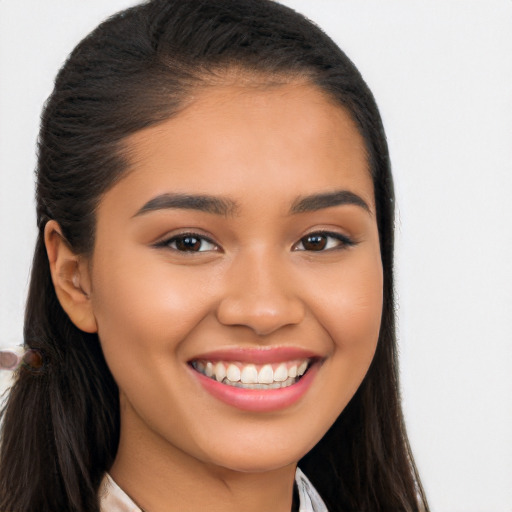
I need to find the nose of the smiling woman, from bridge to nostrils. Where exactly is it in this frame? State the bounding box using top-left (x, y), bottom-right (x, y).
top-left (217, 251), bottom-right (305, 336)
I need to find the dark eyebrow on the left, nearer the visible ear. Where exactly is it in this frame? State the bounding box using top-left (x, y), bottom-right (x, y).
top-left (134, 193), bottom-right (238, 217)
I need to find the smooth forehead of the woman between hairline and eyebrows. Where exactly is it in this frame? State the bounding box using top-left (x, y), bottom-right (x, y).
top-left (108, 84), bottom-right (374, 209)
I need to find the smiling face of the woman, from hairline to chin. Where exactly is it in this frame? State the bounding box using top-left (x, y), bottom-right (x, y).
top-left (89, 85), bottom-right (382, 471)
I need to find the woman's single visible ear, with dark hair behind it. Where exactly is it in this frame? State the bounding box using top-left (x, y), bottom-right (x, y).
top-left (44, 220), bottom-right (98, 332)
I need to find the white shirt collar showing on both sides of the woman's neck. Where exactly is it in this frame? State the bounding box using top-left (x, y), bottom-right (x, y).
top-left (99, 468), bottom-right (328, 512)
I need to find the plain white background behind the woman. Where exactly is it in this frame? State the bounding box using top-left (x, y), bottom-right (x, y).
top-left (0, 0), bottom-right (512, 512)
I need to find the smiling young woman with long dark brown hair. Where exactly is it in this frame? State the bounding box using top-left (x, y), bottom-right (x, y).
top-left (0, 0), bottom-right (427, 512)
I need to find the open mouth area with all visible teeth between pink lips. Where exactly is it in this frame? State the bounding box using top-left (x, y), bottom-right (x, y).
top-left (190, 358), bottom-right (312, 390)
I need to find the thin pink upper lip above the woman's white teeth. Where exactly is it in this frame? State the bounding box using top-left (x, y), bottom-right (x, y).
top-left (191, 347), bottom-right (321, 364)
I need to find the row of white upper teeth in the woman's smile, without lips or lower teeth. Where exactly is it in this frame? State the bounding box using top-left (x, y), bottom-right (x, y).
top-left (193, 359), bottom-right (309, 384)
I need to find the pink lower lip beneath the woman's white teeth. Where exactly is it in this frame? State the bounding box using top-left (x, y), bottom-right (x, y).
top-left (191, 364), bottom-right (319, 412)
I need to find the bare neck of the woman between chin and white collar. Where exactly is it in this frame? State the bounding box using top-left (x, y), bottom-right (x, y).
top-left (110, 402), bottom-right (296, 512)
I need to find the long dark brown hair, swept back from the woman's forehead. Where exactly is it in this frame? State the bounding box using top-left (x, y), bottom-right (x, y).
top-left (0, 0), bottom-right (428, 512)
